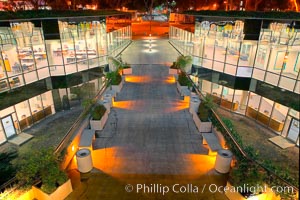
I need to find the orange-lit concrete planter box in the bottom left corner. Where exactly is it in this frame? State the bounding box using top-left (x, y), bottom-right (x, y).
top-left (32, 179), bottom-right (73, 200)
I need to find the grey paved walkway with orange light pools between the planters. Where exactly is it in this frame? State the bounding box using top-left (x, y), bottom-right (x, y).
top-left (67, 59), bottom-right (227, 200)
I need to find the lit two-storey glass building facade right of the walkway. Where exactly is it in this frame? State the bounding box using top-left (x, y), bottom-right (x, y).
top-left (170, 15), bottom-right (300, 146)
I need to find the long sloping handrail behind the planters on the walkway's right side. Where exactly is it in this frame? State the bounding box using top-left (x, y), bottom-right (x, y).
top-left (187, 76), bottom-right (299, 192)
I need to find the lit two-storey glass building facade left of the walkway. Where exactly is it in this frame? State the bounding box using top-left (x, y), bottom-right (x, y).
top-left (0, 15), bottom-right (131, 144)
